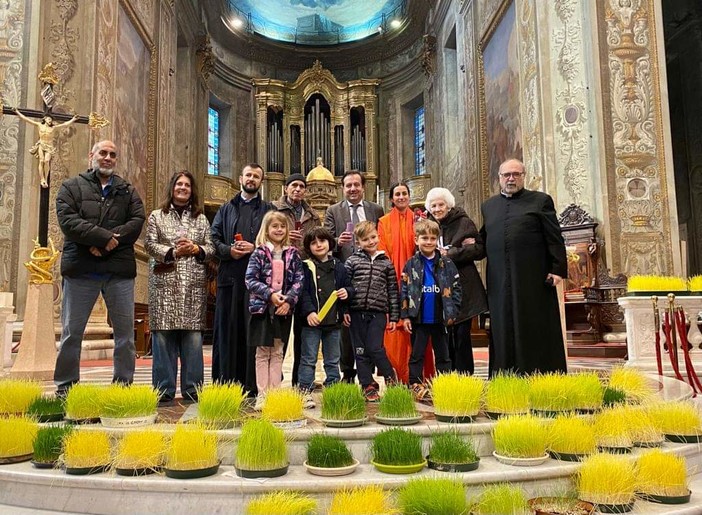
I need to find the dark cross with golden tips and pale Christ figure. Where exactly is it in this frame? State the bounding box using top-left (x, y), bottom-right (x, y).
top-left (0, 63), bottom-right (110, 247)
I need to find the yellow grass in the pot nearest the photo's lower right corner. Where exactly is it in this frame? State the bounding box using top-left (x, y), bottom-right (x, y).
top-left (636, 449), bottom-right (689, 497)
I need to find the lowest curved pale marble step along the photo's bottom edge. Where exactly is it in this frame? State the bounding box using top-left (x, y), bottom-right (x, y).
top-left (0, 458), bottom-right (702, 514)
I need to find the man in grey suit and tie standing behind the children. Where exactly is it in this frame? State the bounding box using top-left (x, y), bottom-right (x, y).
top-left (324, 170), bottom-right (385, 383)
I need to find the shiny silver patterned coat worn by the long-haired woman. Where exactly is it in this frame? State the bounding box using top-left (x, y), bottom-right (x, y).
top-left (146, 209), bottom-right (214, 331)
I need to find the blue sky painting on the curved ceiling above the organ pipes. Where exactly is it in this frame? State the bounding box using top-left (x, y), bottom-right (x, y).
top-left (224, 0), bottom-right (407, 46)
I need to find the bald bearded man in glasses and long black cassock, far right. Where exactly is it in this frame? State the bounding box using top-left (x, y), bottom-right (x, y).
top-left (480, 159), bottom-right (568, 375)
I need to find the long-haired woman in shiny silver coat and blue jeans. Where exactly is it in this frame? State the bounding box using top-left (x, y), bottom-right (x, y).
top-left (146, 170), bottom-right (214, 403)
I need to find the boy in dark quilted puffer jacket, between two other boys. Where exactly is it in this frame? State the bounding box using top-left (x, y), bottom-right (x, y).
top-left (344, 221), bottom-right (400, 402)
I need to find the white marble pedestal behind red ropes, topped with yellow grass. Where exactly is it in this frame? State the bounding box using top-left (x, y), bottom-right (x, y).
top-left (617, 297), bottom-right (702, 377)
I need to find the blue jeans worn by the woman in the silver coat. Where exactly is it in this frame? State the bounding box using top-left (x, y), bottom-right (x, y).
top-left (151, 329), bottom-right (205, 400)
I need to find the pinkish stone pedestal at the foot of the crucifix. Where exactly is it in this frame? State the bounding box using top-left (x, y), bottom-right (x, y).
top-left (10, 284), bottom-right (56, 380)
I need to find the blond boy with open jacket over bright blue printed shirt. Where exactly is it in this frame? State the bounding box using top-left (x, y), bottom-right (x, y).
top-left (400, 220), bottom-right (462, 400)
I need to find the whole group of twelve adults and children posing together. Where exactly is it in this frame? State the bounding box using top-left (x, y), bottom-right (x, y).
top-left (54, 141), bottom-right (566, 407)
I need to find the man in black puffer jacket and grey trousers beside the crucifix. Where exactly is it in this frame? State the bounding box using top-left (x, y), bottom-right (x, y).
top-left (54, 141), bottom-right (145, 395)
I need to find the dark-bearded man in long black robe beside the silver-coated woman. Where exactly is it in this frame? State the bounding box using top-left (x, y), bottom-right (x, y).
top-left (212, 163), bottom-right (275, 396)
